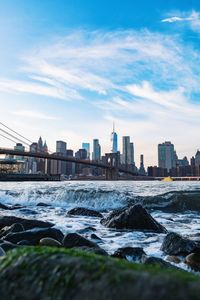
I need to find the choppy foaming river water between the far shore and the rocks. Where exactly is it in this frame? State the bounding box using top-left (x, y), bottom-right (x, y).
top-left (0, 181), bottom-right (200, 268)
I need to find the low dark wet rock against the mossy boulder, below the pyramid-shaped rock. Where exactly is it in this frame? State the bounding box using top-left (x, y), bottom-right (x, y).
top-left (111, 247), bottom-right (146, 262)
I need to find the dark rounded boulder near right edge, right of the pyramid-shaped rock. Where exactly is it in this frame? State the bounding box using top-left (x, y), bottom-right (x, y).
top-left (161, 232), bottom-right (197, 255)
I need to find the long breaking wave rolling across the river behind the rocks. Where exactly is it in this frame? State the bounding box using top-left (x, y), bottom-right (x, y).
top-left (0, 187), bottom-right (200, 212)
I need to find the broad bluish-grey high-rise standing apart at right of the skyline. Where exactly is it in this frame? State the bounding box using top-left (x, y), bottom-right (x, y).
top-left (158, 142), bottom-right (176, 172)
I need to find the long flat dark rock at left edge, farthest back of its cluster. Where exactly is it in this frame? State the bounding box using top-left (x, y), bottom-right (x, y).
top-left (0, 216), bottom-right (54, 230)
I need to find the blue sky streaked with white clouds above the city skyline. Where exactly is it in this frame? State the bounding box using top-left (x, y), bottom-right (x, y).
top-left (0, 0), bottom-right (200, 166)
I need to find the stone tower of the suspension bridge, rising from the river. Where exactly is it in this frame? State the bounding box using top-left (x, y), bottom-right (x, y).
top-left (105, 153), bottom-right (119, 180)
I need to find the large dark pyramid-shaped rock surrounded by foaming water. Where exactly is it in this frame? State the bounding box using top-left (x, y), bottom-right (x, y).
top-left (101, 204), bottom-right (167, 233)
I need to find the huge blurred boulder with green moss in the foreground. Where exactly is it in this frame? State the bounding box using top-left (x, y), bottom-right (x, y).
top-left (0, 247), bottom-right (200, 300)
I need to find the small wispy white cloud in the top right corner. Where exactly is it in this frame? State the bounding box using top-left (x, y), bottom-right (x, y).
top-left (161, 10), bottom-right (200, 32)
